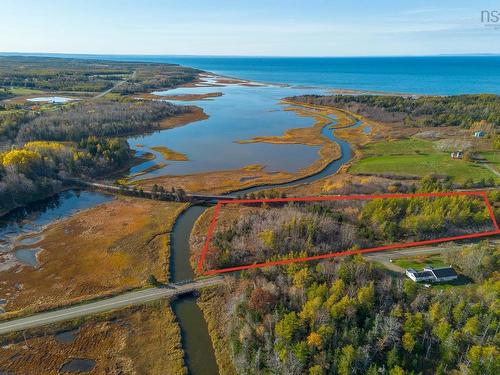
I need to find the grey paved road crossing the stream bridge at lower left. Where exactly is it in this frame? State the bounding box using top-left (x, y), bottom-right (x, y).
top-left (0, 277), bottom-right (224, 334)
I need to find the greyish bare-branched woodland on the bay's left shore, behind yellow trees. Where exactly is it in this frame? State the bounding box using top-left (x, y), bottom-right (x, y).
top-left (15, 100), bottom-right (190, 142)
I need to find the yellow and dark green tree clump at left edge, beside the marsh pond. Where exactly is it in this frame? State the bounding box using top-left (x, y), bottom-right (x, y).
top-left (0, 136), bottom-right (131, 213)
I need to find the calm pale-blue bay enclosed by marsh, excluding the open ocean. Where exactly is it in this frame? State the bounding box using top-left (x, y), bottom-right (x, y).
top-left (128, 85), bottom-right (324, 178)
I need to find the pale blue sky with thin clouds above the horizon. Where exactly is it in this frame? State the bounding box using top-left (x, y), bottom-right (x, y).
top-left (0, 0), bottom-right (500, 56)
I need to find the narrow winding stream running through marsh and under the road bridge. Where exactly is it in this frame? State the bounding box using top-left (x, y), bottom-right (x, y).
top-left (170, 107), bottom-right (362, 375)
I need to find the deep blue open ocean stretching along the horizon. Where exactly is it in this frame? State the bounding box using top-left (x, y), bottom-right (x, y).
top-left (3, 54), bottom-right (500, 95)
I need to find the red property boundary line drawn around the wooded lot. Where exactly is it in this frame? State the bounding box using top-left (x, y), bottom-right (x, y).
top-left (196, 191), bottom-right (500, 276)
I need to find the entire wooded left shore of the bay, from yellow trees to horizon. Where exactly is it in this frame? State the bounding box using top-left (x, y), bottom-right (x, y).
top-left (0, 56), bottom-right (203, 214)
